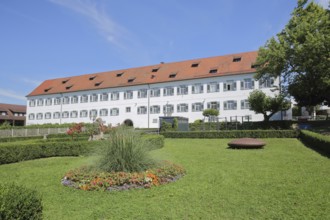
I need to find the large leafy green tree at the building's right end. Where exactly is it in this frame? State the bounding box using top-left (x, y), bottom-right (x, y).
top-left (255, 0), bottom-right (330, 107)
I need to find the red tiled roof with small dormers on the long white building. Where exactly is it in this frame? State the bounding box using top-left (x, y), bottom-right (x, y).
top-left (27, 51), bottom-right (257, 96)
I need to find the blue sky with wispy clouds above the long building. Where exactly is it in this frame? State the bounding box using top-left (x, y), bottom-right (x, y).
top-left (0, 0), bottom-right (328, 104)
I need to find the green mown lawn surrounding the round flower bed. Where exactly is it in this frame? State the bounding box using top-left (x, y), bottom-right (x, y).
top-left (0, 139), bottom-right (330, 219)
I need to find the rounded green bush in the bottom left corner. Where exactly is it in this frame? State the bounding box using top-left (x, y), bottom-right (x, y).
top-left (0, 184), bottom-right (42, 220)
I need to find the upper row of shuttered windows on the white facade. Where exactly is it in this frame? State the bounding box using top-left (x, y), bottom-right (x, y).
top-left (29, 78), bottom-right (274, 107)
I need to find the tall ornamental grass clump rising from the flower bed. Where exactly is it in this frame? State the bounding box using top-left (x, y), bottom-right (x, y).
top-left (97, 126), bottom-right (155, 172)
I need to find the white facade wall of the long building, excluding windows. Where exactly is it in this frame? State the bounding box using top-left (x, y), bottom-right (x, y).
top-left (26, 74), bottom-right (279, 128)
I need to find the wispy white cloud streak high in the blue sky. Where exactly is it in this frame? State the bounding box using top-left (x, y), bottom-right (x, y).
top-left (49, 0), bottom-right (130, 48)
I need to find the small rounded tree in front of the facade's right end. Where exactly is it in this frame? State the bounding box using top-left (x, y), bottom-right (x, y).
top-left (248, 90), bottom-right (290, 121)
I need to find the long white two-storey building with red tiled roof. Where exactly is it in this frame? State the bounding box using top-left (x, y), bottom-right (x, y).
top-left (26, 52), bottom-right (286, 128)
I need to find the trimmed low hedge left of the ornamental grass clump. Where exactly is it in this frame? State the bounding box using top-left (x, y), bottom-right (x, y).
top-left (0, 140), bottom-right (98, 164)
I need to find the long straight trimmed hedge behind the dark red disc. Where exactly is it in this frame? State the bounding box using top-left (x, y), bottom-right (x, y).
top-left (161, 130), bottom-right (299, 138)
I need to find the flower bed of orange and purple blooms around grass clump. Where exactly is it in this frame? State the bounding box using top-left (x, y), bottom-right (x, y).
top-left (61, 161), bottom-right (185, 191)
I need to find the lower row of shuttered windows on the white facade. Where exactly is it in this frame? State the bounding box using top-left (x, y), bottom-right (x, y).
top-left (29, 100), bottom-right (250, 120)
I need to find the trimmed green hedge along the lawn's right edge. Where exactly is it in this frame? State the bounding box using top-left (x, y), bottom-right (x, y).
top-left (299, 130), bottom-right (330, 155)
